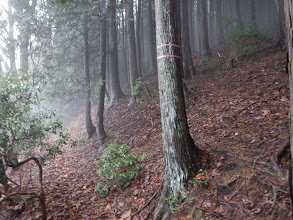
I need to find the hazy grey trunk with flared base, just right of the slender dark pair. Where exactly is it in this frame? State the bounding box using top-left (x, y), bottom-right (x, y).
top-left (108, 0), bottom-right (123, 106)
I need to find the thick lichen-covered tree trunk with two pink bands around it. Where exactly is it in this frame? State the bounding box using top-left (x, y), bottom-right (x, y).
top-left (154, 0), bottom-right (199, 219)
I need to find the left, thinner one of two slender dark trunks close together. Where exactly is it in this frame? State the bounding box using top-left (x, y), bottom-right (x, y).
top-left (83, 19), bottom-right (96, 139)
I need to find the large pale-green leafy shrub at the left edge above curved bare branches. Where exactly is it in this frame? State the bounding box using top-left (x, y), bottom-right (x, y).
top-left (0, 72), bottom-right (69, 164)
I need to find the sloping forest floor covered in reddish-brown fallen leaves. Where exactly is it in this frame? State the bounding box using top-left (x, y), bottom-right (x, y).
top-left (4, 45), bottom-right (290, 220)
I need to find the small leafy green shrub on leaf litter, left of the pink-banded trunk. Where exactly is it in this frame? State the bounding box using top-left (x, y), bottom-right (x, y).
top-left (96, 141), bottom-right (146, 196)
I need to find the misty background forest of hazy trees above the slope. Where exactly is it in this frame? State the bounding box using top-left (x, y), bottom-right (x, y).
top-left (0, 0), bottom-right (284, 124)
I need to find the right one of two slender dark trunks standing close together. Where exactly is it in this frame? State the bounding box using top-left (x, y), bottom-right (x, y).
top-left (97, 2), bottom-right (107, 145)
